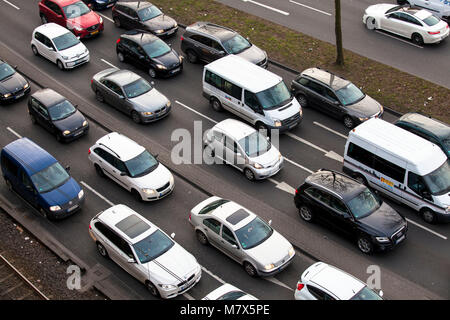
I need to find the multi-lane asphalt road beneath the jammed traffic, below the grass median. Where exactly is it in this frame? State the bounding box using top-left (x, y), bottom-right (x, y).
top-left (0, 0), bottom-right (450, 299)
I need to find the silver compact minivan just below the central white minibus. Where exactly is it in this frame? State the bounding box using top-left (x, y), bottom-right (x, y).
top-left (204, 119), bottom-right (284, 180)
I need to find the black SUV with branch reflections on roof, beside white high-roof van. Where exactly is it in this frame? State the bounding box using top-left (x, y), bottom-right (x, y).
top-left (294, 169), bottom-right (408, 254)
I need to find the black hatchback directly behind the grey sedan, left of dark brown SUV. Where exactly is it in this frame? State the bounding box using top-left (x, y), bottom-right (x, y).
top-left (116, 31), bottom-right (183, 78)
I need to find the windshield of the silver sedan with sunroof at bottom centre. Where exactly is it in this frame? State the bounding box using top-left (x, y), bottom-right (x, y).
top-left (235, 217), bottom-right (273, 250)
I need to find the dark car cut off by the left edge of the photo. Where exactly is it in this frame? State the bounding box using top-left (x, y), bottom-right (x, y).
top-left (0, 59), bottom-right (30, 103)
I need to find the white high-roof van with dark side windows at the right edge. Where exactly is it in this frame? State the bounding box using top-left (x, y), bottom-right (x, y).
top-left (343, 119), bottom-right (450, 223)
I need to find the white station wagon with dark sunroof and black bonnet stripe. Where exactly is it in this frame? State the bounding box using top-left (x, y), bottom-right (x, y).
top-left (89, 204), bottom-right (202, 299)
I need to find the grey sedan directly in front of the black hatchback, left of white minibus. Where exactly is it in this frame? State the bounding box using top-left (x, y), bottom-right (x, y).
top-left (91, 68), bottom-right (171, 123)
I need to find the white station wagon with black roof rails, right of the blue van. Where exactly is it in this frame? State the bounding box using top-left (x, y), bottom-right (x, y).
top-left (88, 132), bottom-right (175, 201)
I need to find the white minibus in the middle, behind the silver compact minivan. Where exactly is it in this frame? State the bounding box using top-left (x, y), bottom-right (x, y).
top-left (203, 55), bottom-right (303, 132)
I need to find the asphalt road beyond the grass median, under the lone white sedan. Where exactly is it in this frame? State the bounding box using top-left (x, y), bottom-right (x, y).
top-left (216, 0), bottom-right (450, 88)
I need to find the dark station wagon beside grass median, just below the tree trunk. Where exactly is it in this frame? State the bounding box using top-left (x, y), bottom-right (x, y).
top-left (291, 68), bottom-right (383, 129)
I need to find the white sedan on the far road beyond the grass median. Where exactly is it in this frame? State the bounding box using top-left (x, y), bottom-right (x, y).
top-left (363, 3), bottom-right (450, 45)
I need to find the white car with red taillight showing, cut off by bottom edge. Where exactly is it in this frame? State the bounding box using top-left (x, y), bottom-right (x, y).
top-left (294, 262), bottom-right (383, 300)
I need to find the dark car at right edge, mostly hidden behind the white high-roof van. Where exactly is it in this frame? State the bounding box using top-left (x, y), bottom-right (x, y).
top-left (394, 112), bottom-right (450, 158)
